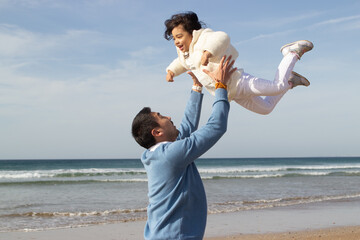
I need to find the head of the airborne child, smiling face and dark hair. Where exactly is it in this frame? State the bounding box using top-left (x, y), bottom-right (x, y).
top-left (164, 12), bottom-right (204, 52)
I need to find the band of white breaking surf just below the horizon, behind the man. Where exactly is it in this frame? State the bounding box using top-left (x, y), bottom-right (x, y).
top-left (0, 163), bottom-right (360, 185)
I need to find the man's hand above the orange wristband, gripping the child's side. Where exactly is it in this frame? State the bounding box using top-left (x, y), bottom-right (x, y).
top-left (203, 56), bottom-right (237, 85)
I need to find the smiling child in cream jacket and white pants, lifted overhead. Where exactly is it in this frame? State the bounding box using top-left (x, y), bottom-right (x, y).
top-left (164, 12), bottom-right (313, 115)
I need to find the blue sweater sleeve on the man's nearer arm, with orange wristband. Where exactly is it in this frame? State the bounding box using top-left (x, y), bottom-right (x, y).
top-left (163, 88), bottom-right (230, 168)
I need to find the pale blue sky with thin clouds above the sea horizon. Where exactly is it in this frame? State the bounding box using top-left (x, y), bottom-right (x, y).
top-left (0, 0), bottom-right (360, 159)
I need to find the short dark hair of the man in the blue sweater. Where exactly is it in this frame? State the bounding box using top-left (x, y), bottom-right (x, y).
top-left (131, 107), bottom-right (160, 149)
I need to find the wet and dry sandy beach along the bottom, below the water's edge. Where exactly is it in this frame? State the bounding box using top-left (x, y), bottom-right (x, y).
top-left (0, 201), bottom-right (360, 240)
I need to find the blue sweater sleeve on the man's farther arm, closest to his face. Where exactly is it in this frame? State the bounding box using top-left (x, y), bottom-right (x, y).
top-left (177, 91), bottom-right (203, 140)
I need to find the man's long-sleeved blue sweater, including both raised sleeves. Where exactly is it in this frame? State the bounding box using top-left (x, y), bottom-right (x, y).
top-left (141, 88), bottom-right (230, 240)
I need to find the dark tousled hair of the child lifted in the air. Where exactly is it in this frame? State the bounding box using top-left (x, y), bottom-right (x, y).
top-left (164, 11), bottom-right (205, 40)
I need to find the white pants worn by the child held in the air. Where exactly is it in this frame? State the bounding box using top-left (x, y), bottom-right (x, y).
top-left (233, 53), bottom-right (298, 115)
